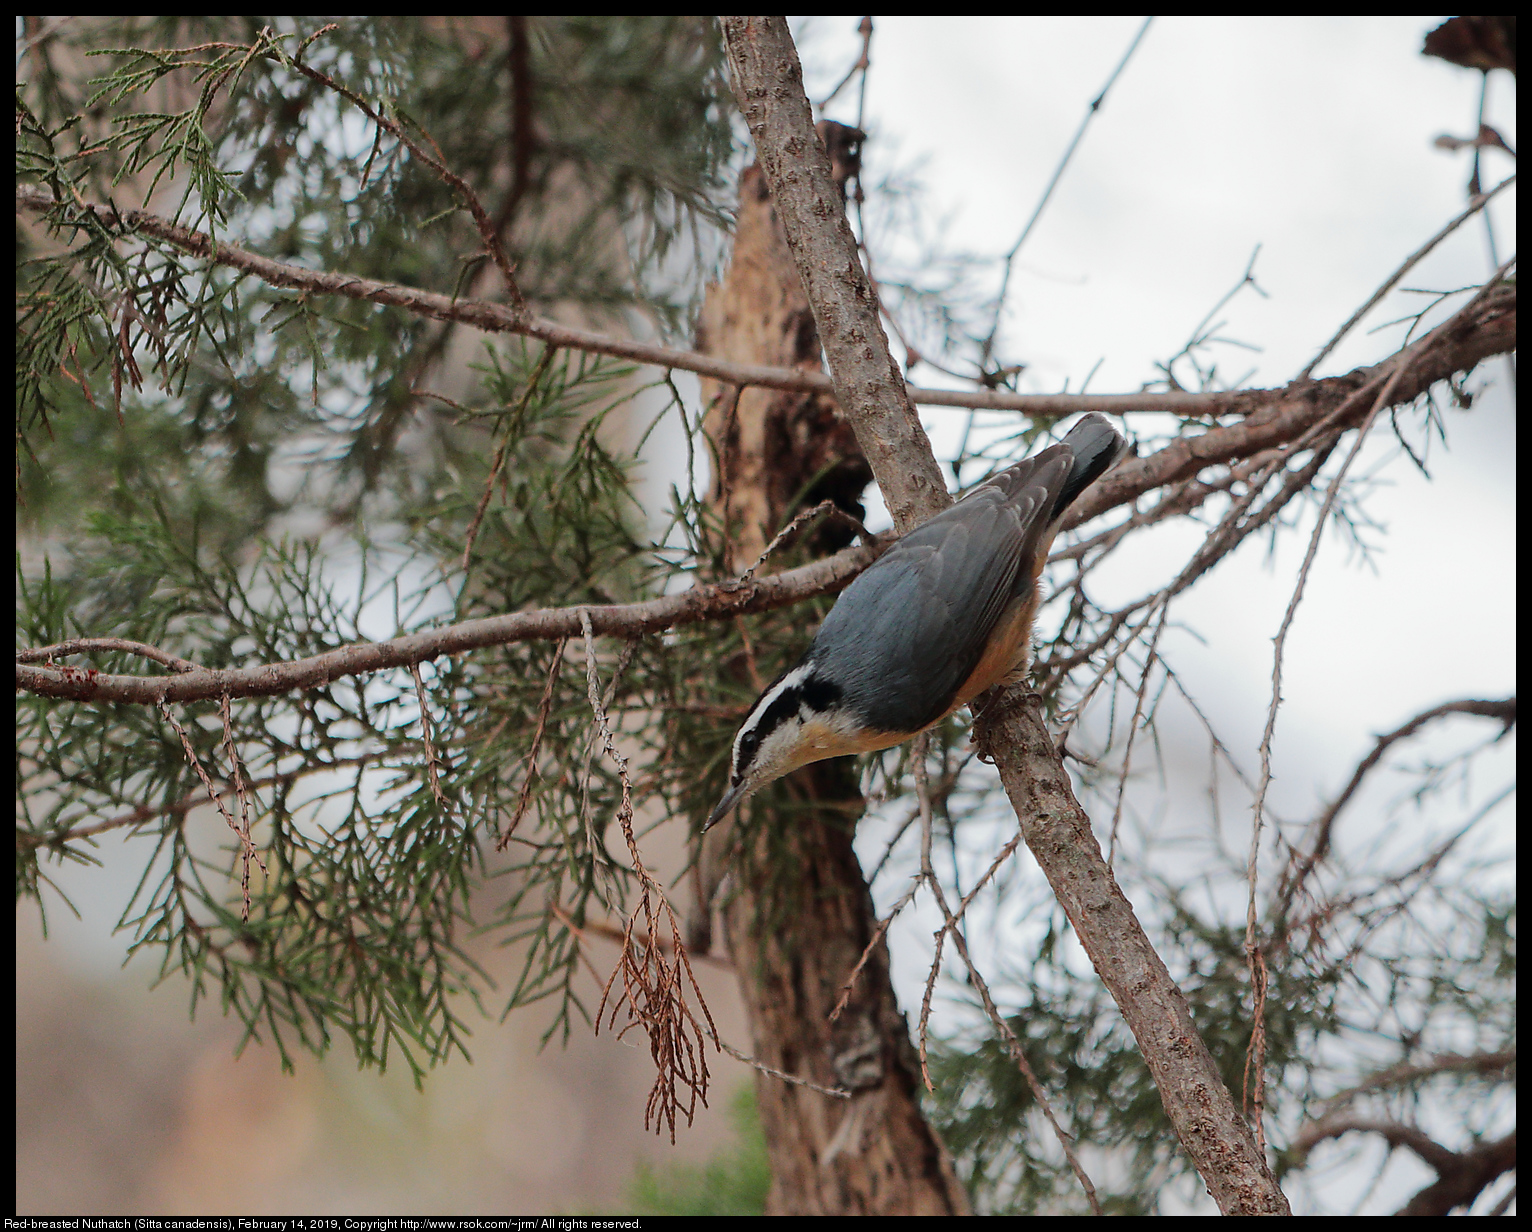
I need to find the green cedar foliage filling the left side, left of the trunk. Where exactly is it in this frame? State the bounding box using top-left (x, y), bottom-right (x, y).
top-left (17, 17), bottom-right (735, 1077)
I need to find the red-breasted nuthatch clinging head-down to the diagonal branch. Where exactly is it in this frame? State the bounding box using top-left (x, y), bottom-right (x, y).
top-left (703, 414), bottom-right (1128, 831)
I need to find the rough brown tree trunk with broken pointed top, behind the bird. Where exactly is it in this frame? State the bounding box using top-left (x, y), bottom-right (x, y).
top-left (697, 156), bottom-right (968, 1215)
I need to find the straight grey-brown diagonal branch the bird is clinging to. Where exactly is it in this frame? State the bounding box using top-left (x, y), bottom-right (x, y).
top-left (722, 17), bottom-right (1287, 1214)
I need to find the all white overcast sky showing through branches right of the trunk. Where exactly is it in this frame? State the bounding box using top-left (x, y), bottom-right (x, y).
top-left (794, 15), bottom-right (1517, 1212)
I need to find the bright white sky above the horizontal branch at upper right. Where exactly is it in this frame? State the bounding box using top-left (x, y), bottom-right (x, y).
top-left (800, 17), bottom-right (1515, 384)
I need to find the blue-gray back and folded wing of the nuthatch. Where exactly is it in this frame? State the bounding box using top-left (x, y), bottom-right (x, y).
top-left (809, 444), bottom-right (1074, 732)
